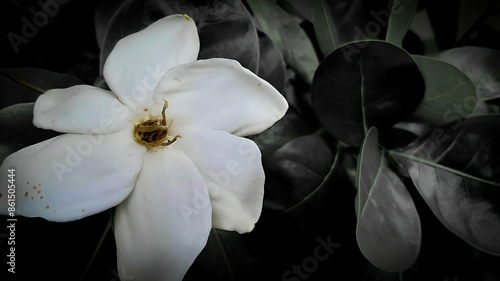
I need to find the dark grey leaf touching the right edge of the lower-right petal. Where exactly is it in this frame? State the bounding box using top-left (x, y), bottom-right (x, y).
top-left (263, 135), bottom-right (335, 208)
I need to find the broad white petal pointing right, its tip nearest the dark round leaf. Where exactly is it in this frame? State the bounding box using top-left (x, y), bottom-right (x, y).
top-left (154, 59), bottom-right (288, 136)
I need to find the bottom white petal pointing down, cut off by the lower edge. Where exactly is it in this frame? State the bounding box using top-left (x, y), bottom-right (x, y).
top-left (114, 147), bottom-right (212, 281)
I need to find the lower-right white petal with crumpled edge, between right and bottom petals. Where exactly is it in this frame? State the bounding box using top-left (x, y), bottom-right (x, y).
top-left (171, 127), bottom-right (265, 233)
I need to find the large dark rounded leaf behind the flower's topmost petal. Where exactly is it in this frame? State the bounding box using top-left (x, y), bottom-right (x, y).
top-left (100, 0), bottom-right (259, 72)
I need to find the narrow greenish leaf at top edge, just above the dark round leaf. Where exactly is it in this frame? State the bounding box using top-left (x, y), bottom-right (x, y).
top-left (311, 0), bottom-right (340, 56)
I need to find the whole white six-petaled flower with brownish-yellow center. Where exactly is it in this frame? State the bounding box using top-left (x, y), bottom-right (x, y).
top-left (0, 15), bottom-right (288, 281)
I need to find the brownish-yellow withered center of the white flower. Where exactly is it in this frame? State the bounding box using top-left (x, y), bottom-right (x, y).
top-left (134, 101), bottom-right (181, 147)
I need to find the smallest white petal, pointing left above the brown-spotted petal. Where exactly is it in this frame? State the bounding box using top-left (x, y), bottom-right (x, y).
top-left (33, 85), bottom-right (129, 134)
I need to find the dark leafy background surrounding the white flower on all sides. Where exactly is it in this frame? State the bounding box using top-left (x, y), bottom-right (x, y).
top-left (0, 0), bottom-right (500, 281)
